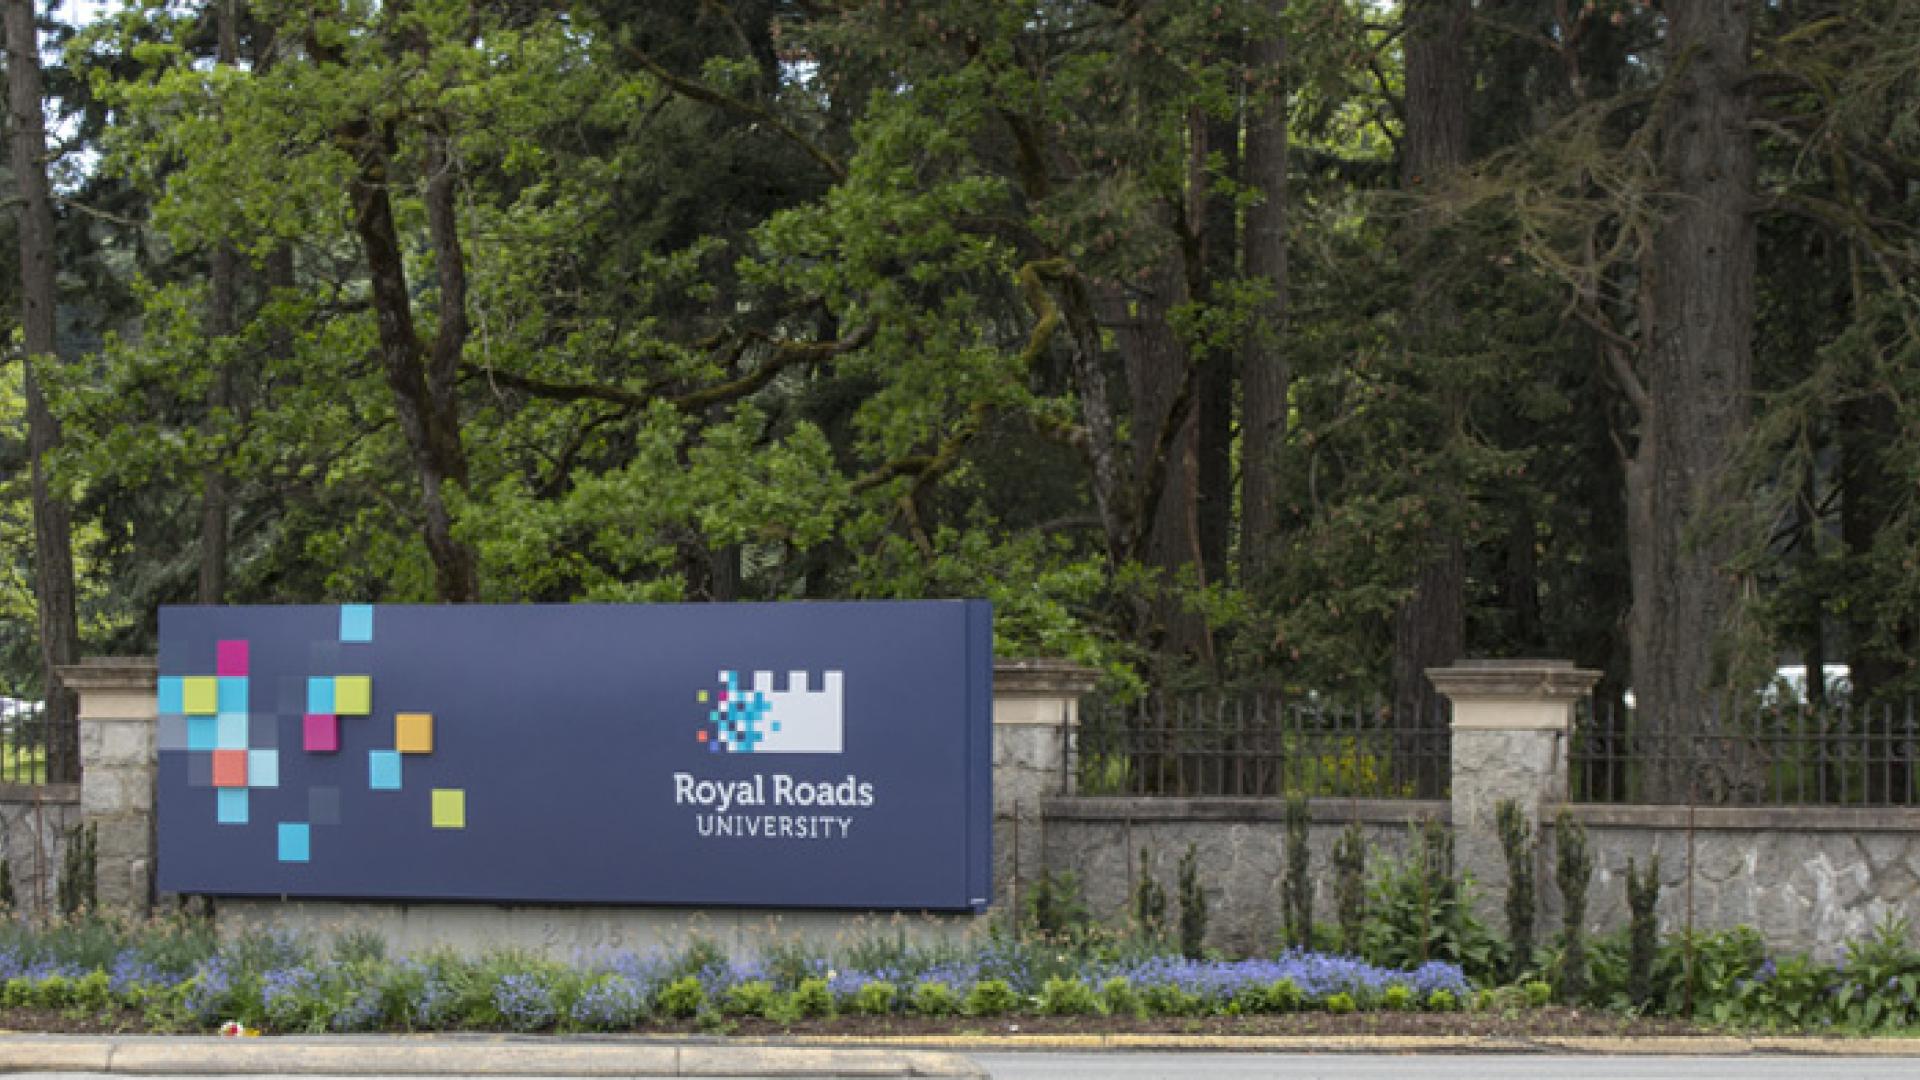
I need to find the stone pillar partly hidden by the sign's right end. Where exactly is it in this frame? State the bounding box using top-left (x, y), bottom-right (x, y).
top-left (993, 659), bottom-right (1098, 911)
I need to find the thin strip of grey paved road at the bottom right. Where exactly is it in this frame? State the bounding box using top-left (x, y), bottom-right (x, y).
top-left (968, 1053), bottom-right (1920, 1080)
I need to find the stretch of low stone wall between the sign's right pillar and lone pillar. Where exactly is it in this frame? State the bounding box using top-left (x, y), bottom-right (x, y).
top-left (1044, 798), bottom-right (1450, 955)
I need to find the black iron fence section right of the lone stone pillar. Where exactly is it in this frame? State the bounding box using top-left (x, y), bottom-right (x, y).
top-left (1569, 701), bottom-right (1920, 807)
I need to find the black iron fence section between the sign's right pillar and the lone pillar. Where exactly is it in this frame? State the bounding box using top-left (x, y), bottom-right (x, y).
top-left (1073, 692), bottom-right (1452, 799)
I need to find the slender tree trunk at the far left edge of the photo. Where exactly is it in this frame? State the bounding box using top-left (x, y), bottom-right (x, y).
top-left (6, 0), bottom-right (81, 780)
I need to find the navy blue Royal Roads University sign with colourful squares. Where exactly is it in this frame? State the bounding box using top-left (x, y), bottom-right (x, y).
top-left (157, 601), bottom-right (993, 909)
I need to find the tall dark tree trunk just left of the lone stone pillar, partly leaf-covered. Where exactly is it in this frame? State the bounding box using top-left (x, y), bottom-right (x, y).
top-left (1392, 0), bottom-right (1471, 796)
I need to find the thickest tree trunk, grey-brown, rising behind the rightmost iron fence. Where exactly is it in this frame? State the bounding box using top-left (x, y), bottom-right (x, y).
top-left (1632, 0), bottom-right (1755, 798)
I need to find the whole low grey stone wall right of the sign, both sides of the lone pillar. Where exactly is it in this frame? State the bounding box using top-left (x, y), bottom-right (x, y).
top-left (1044, 798), bottom-right (1920, 959)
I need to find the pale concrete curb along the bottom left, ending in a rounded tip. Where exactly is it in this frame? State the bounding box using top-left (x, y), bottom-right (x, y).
top-left (0, 1036), bottom-right (987, 1078)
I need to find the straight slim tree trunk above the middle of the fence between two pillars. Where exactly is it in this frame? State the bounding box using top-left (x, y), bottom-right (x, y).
top-left (1240, 16), bottom-right (1292, 588)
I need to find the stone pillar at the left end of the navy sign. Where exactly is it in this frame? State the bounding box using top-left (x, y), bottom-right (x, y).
top-left (60, 657), bottom-right (159, 917)
